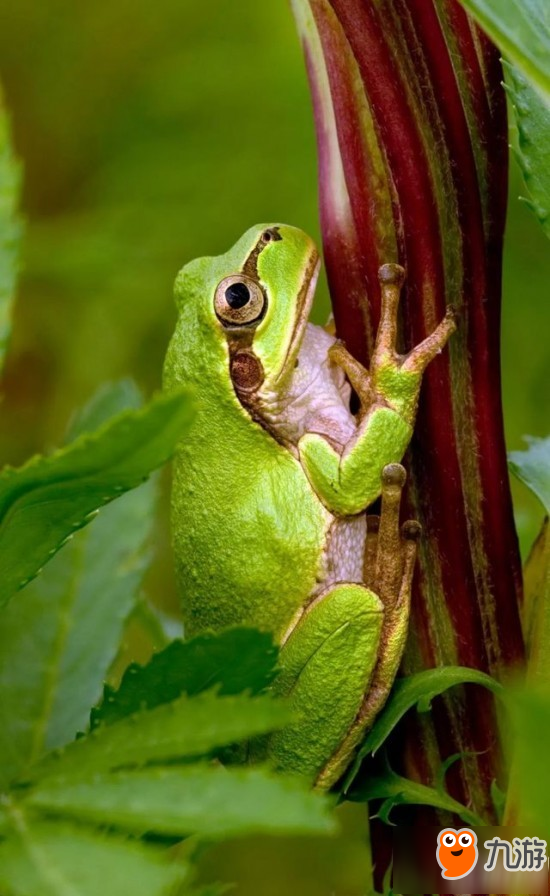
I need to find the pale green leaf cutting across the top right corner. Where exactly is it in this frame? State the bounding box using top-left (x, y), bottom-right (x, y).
top-left (461, 0), bottom-right (550, 103)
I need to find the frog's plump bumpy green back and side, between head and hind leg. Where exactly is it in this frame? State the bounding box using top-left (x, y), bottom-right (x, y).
top-left (172, 394), bottom-right (331, 635)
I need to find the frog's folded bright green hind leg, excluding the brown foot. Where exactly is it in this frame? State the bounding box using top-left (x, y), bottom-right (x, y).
top-left (268, 583), bottom-right (383, 781)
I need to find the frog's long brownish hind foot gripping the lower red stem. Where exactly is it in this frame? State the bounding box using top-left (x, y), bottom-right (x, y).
top-left (316, 464), bottom-right (422, 788)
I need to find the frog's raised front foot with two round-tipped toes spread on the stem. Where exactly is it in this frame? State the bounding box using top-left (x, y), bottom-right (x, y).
top-left (370, 264), bottom-right (456, 417)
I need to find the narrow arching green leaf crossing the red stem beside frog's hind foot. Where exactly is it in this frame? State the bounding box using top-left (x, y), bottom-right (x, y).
top-left (350, 666), bottom-right (504, 790)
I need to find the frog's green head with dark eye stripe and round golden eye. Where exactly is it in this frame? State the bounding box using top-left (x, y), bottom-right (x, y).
top-left (172, 224), bottom-right (320, 403)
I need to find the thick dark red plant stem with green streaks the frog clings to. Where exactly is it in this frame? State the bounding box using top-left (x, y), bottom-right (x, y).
top-left (294, 0), bottom-right (523, 818)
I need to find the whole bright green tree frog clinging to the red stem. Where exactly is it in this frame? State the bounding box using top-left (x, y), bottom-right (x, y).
top-left (164, 224), bottom-right (455, 788)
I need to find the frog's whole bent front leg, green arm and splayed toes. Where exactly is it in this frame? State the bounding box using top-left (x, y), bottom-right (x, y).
top-left (298, 264), bottom-right (456, 516)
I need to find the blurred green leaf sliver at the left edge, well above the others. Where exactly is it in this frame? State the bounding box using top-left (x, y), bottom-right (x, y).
top-left (0, 90), bottom-right (22, 367)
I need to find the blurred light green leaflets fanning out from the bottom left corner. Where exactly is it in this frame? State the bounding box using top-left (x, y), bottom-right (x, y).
top-left (0, 632), bottom-right (334, 896)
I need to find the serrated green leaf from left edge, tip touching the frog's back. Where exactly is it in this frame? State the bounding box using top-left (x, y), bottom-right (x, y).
top-left (0, 393), bottom-right (191, 606)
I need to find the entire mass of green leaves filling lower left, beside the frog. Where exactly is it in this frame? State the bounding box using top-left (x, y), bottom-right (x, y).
top-left (0, 382), bottom-right (334, 896)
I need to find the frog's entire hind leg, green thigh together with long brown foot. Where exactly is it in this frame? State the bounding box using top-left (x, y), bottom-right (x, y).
top-left (269, 464), bottom-right (420, 788)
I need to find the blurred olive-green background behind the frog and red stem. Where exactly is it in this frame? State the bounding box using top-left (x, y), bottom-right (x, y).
top-left (0, 0), bottom-right (550, 896)
